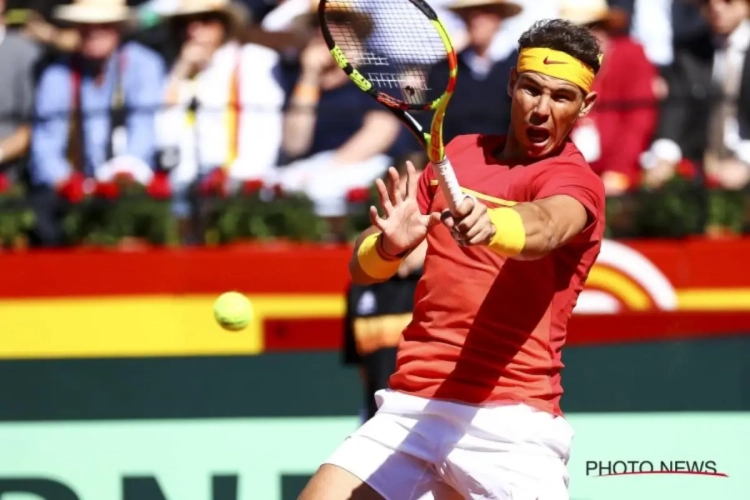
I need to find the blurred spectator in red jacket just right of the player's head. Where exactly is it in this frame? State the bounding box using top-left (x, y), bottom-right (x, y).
top-left (560, 0), bottom-right (658, 196)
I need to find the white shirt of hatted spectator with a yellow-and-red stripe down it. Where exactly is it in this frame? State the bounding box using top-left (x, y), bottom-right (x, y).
top-left (157, 42), bottom-right (284, 184)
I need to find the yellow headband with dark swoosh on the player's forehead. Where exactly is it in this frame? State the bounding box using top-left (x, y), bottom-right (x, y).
top-left (517, 47), bottom-right (601, 93)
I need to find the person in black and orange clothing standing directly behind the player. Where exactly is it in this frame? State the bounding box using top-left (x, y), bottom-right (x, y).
top-left (343, 152), bottom-right (427, 420)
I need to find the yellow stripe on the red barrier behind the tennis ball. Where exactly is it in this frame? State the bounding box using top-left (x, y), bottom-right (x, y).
top-left (0, 295), bottom-right (344, 359)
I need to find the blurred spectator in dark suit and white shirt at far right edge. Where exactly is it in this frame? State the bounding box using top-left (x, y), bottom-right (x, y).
top-left (642, 0), bottom-right (750, 189)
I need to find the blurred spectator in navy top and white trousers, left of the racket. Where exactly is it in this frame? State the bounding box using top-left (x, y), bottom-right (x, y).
top-left (279, 2), bottom-right (401, 235)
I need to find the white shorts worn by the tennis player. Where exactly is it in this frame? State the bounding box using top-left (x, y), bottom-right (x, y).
top-left (325, 390), bottom-right (573, 500)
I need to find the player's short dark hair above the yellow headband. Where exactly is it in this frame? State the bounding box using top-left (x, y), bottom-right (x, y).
top-left (518, 19), bottom-right (601, 74)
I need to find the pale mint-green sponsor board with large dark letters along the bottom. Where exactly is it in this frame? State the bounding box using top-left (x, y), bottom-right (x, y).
top-left (0, 413), bottom-right (750, 500)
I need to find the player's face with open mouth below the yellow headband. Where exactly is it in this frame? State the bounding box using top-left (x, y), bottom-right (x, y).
top-left (508, 69), bottom-right (596, 158)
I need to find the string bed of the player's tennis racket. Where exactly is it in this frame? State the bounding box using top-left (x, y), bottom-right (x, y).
top-left (324, 0), bottom-right (449, 107)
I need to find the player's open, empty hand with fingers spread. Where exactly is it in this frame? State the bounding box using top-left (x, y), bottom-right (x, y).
top-left (370, 162), bottom-right (440, 256)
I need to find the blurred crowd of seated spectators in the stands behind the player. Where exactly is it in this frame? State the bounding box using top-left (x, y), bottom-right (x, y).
top-left (0, 0), bottom-right (750, 246)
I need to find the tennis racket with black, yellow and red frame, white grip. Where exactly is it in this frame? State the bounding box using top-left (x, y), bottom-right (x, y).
top-left (318, 0), bottom-right (465, 213)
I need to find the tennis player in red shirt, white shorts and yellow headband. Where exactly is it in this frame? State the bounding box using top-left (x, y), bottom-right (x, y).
top-left (301, 20), bottom-right (604, 500)
